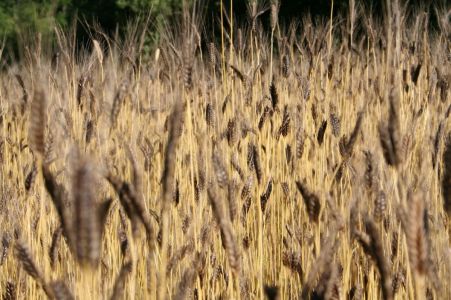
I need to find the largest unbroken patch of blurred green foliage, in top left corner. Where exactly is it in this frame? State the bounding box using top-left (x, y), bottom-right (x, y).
top-left (0, 0), bottom-right (187, 54)
